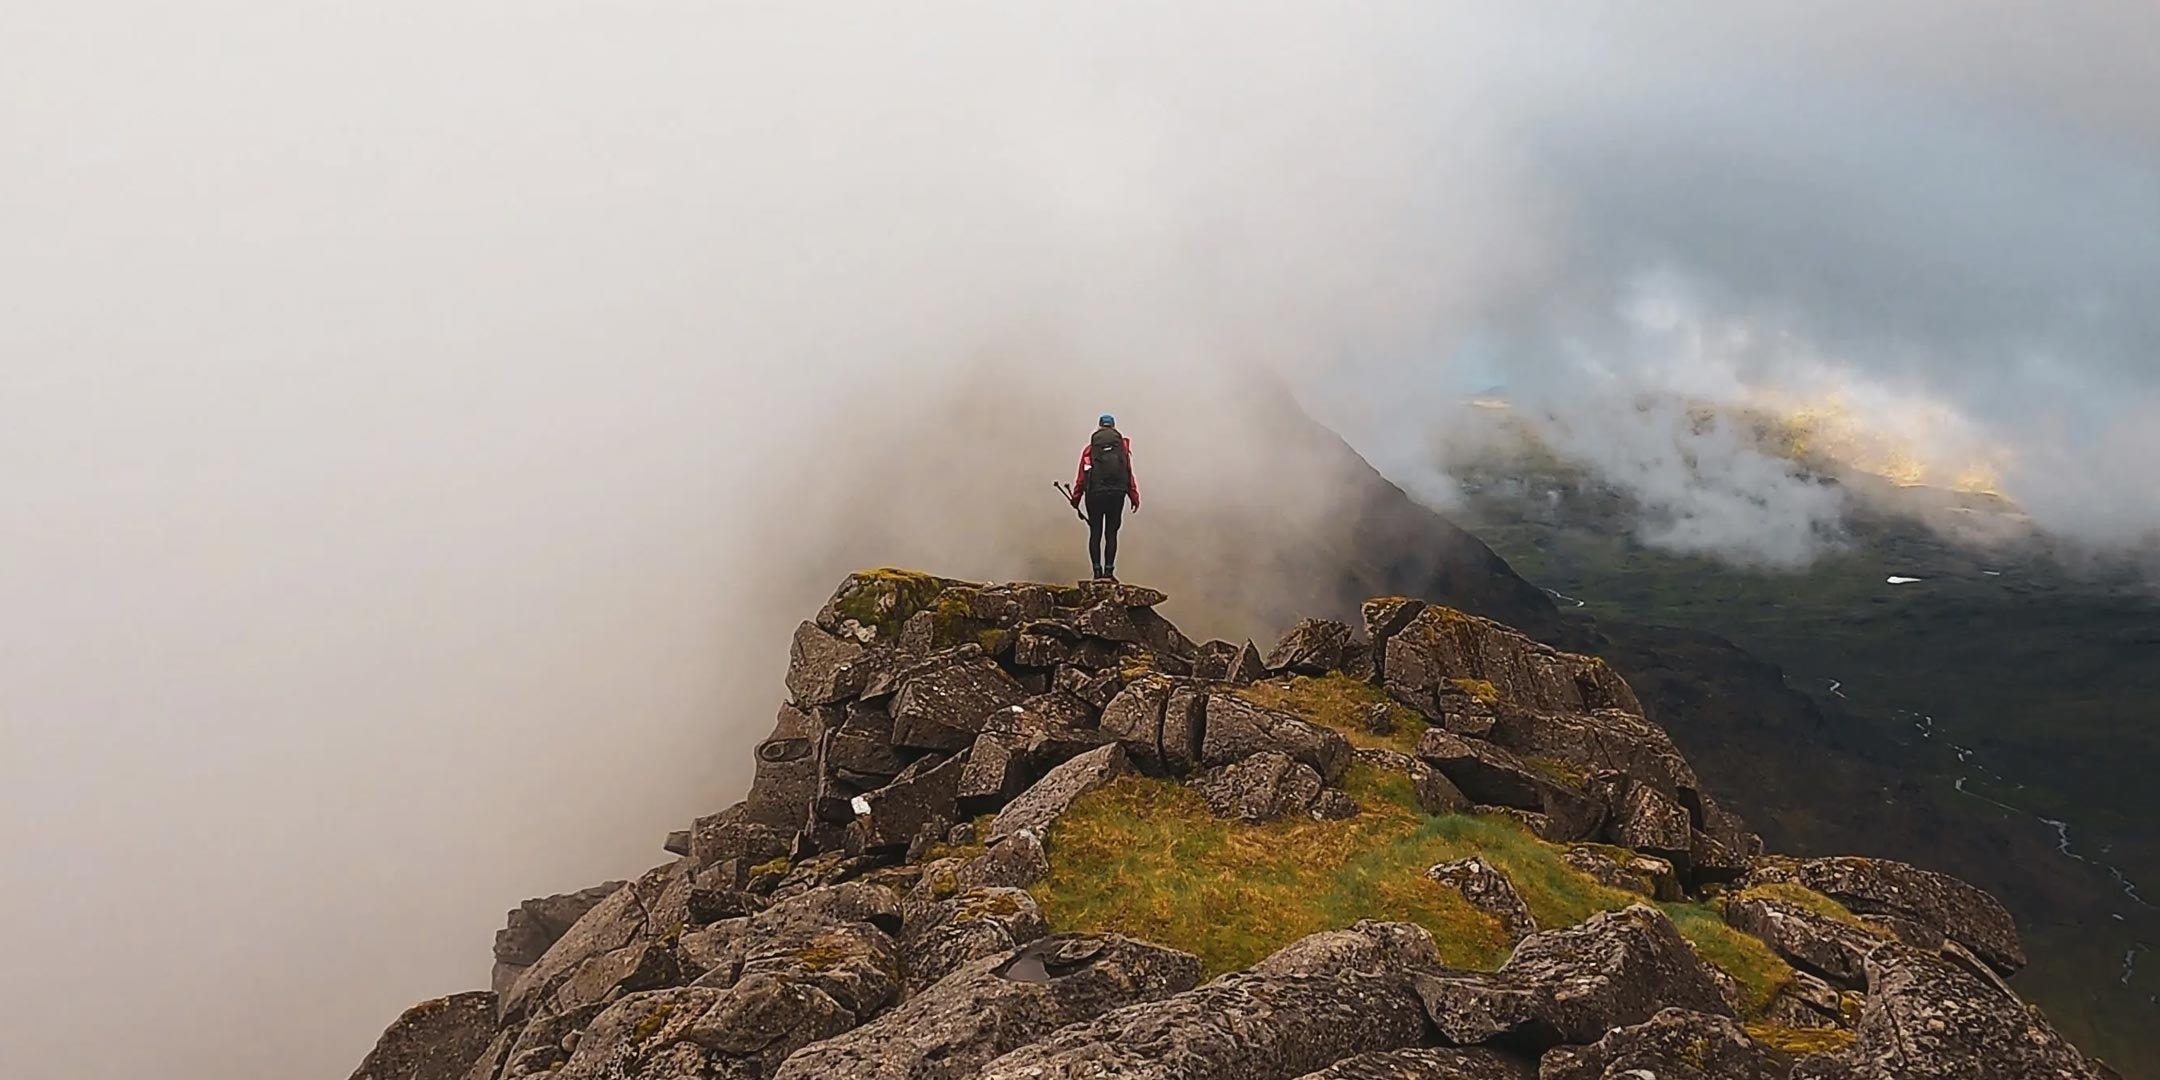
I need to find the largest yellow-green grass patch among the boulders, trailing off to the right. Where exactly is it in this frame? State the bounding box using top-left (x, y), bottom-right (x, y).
top-left (1032, 762), bottom-right (1791, 1013)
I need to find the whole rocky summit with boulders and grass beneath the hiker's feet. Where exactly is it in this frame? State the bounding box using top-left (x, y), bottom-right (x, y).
top-left (354, 570), bottom-right (2112, 1080)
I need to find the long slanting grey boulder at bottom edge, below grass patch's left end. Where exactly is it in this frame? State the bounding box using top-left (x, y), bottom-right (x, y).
top-left (773, 935), bottom-right (1201, 1080)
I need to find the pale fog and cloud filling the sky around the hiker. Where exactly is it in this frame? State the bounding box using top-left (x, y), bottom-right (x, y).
top-left (0, 0), bottom-right (2160, 1078)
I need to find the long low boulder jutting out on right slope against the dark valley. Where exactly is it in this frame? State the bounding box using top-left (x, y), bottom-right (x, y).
top-left (1747, 855), bottom-right (2026, 974)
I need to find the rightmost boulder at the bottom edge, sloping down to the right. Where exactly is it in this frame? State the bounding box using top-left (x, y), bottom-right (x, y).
top-left (1836, 944), bottom-right (2110, 1080)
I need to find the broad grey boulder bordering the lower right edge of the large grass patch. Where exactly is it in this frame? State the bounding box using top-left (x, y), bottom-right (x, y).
top-left (1415, 905), bottom-right (1732, 1050)
